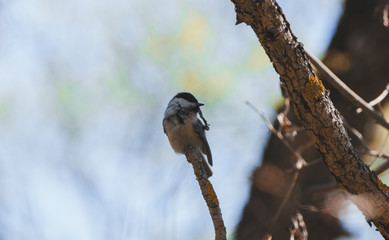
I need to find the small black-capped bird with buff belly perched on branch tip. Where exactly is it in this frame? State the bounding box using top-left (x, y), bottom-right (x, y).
top-left (162, 92), bottom-right (212, 177)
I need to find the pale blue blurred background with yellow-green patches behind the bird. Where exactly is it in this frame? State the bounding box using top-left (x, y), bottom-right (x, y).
top-left (0, 0), bottom-right (382, 240)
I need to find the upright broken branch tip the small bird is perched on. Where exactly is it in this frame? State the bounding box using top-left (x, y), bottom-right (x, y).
top-left (185, 146), bottom-right (227, 240)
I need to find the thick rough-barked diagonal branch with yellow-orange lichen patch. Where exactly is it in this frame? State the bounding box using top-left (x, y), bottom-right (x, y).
top-left (232, 0), bottom-right (389, 239)
